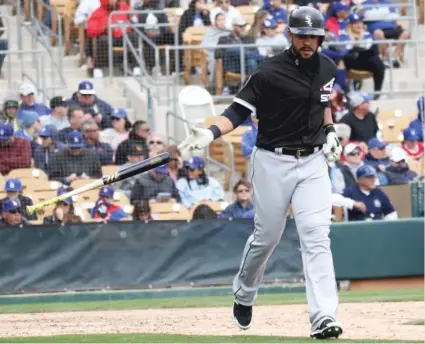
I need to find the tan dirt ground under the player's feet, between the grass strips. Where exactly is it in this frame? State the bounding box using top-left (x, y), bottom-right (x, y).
top-left (0, 302), bottom-right (424, 341)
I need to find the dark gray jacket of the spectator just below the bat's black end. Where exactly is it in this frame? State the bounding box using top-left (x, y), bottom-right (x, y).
top-left (130, 166), bottom-right (180, 203)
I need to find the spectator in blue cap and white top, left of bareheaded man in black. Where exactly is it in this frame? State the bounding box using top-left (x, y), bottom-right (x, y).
top-left (99, 108), bottom-right (131, 152)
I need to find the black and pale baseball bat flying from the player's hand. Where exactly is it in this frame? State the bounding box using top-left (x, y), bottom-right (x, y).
top-left (27, 153), bottom-right (171, 215)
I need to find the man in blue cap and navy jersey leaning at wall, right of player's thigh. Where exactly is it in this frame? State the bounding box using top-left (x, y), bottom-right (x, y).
top-left (343, 165), bottom-right (398, 221)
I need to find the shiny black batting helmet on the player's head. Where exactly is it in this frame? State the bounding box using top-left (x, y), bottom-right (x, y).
top-left (289, 6), bottom-right (325, 36)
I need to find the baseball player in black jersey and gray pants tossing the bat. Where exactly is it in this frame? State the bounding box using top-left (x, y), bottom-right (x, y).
top-left (181, 7), bottom-right (342, 339)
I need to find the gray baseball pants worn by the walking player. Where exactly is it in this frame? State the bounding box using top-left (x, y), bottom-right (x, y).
top-left (233, 147), bottom-right (338, 330)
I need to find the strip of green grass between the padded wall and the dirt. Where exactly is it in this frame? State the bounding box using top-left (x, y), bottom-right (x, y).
top-left (0, 289), bottom-right (424, 313)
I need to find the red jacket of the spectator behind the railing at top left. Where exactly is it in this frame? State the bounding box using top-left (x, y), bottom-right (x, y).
top-left (87, 0), bottom-right (131, 38)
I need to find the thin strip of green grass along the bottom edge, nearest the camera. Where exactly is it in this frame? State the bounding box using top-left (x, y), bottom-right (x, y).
top-left (0, 334), bottom-right (421, 344)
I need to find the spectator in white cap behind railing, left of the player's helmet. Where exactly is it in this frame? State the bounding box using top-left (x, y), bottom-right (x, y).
top-left (215, 17), bottom-right (263, 74)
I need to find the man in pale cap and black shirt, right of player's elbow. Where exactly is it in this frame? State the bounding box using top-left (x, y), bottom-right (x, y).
top-left (340, 92), bottom-right (379, 142)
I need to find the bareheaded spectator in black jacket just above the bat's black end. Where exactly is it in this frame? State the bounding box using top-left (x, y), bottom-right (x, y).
top-left (115, 120), bottom-right (150, 165)
